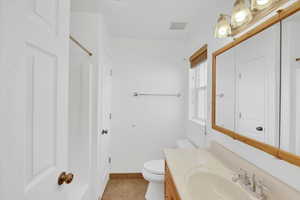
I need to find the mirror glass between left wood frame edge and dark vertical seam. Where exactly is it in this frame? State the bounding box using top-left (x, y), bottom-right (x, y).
top-left (216, 24), bottom-right (280, 146)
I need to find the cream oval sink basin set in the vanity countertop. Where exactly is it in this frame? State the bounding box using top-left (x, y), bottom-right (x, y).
top-left (186, 170), bottom-right (253, 200)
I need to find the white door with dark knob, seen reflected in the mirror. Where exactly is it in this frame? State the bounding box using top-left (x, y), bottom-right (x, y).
top-left (237, 58), bottom-right (267, 141)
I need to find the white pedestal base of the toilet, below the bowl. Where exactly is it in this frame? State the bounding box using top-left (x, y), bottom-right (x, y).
top-left (145, 182), bottom-right (165, 200)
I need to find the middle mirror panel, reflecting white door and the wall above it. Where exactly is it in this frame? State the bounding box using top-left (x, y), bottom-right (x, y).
top-left (236, 25), bottom-right (280, 145)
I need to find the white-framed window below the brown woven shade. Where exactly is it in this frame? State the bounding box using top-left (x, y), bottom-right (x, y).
top-left (189, 60), bottom-right (207, 125)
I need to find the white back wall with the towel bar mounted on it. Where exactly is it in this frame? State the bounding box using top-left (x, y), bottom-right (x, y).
top-left (111, 38), bottom-right (186, 173)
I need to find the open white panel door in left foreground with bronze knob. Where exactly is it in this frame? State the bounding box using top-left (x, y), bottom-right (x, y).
top-left (0, 0), bottom-right (70, 200)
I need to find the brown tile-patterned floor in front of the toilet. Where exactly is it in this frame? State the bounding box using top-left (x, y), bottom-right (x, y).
top-left (102, 179), bottom-right (148, 200)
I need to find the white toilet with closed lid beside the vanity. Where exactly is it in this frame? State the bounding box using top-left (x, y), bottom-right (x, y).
top-left (142, 140), bottom-right (195, 200)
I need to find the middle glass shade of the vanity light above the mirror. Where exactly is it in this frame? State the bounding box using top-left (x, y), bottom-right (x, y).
top-left (231, 0), bottom-right (253, 28)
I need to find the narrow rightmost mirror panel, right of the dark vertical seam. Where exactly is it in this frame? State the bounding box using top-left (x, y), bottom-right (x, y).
top-left (280, 13), bottom-right (300, 155)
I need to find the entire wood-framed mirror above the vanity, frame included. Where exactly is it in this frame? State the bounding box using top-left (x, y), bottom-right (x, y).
top-left (212, 1), bottom-right (300, 166)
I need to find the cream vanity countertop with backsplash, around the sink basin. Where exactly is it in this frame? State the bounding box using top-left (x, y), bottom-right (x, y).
top-left (164, 142), bottom-right (300, 200)
